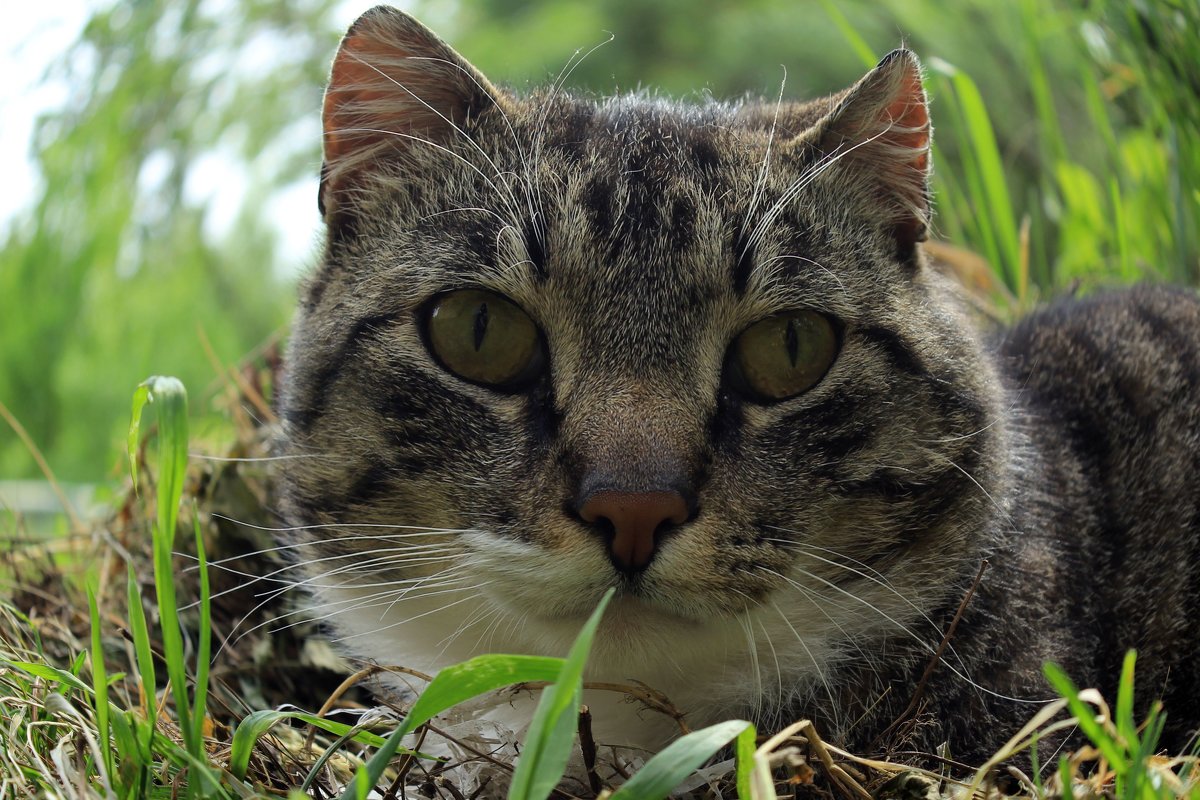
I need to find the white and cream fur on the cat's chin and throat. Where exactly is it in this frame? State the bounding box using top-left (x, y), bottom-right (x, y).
top-left (319, 575), bottom-right (834, 750)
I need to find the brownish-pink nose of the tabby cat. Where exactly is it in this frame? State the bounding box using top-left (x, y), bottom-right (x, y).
top-left (580, 492), bottom-right (688, 571)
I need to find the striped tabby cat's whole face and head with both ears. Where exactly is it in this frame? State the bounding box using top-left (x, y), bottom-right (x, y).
top-left (280, 3), bottom-right (1003, 734)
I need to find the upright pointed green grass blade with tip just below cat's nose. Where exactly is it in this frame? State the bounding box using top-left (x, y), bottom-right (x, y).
top-left (509, 589), bottom-right (616, 800)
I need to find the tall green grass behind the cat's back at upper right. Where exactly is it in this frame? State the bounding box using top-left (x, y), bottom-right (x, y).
top-left (822, 0), bottom-right (1200, 312)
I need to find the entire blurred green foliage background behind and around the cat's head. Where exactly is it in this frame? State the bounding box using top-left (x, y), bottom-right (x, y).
top-left (0, 0), bottom-right (1200, 482)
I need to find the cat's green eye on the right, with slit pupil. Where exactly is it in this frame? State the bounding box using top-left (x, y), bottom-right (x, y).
top-left (730, 311), bottom-right (838, 401)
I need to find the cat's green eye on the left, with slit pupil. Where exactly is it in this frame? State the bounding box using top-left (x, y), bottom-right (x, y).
top-left (426, 289), bottom-right (545, 389)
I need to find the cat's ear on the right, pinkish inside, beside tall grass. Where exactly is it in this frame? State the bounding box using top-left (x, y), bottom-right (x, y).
top-left (803, 49), bottom-right (932, 253)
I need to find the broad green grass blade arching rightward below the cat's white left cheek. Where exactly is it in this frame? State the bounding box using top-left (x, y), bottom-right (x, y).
top-left (341, 655), bottom-right (563, 800)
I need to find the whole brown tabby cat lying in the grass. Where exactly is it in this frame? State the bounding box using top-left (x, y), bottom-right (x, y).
top-left (277, 6), bottom-right (1200, 763)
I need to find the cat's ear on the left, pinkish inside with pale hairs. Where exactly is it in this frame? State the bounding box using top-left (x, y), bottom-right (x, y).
top-left (318, 6), bottom-right (505, 222)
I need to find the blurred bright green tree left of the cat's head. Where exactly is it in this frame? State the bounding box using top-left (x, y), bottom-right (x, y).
top-left (0, 0), bottom-right (338, 480)
